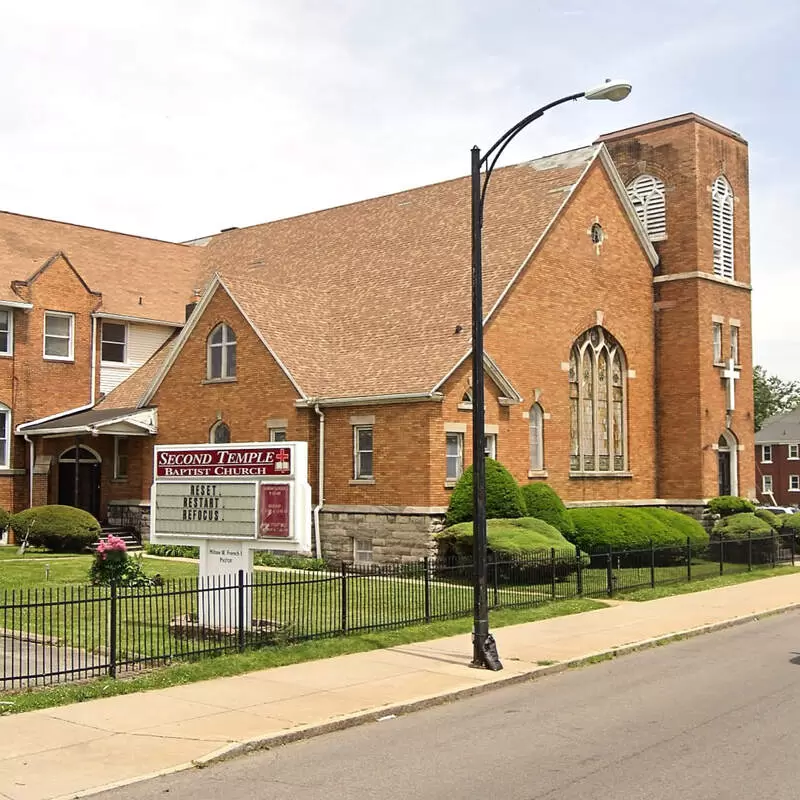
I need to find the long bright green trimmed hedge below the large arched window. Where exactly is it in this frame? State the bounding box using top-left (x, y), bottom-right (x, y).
top-left (567, 507), bottom-right (708, 552)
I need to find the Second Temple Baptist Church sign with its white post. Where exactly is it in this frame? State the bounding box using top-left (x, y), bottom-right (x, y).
top-left (150, 442), bottom-right (311, 628)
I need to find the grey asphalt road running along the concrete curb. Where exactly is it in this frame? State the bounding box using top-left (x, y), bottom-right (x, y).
top-left (98, 613), bottom-right (800, 800)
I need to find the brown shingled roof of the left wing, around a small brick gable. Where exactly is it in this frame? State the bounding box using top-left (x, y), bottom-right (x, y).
top-left (0, 212), bottom-right (203, 325)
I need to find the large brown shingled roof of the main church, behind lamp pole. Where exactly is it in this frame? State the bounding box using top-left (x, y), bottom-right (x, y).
top-left (170, 146), bottom-right (604, 398)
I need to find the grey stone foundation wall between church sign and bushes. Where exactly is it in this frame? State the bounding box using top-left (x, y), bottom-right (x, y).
top-left (320, 506), bottom-right (445, 564)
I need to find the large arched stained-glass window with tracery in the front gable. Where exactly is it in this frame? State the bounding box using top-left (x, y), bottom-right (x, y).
top-left (569, 326), bottom-right (628, 472)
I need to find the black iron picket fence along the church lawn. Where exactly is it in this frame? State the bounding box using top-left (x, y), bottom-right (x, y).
top-left (0, 534), bottom-right (798, 690)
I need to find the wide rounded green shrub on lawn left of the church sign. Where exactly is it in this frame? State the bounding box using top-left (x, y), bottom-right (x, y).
top-left (11, 506), bottom-right (100, 553)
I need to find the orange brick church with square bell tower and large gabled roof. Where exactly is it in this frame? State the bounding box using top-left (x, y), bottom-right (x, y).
top-left (9, 114), bottom-right (755, 560)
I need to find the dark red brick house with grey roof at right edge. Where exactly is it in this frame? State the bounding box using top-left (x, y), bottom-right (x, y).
top-left (755, 408), bottom-right (800, 506)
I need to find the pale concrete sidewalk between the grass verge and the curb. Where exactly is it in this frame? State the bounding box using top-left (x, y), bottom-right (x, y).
top-left (0, 573), bottom-right (800, 800)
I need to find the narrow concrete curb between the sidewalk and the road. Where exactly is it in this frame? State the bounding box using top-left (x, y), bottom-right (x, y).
top-left (52, 602), bottom-right (800, 800)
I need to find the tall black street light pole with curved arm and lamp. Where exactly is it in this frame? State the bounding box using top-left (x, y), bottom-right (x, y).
top-left (470, 80), bottom-right (631, 670)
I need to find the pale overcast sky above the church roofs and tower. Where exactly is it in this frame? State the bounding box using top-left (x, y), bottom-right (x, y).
top-left (0, 0), bottom-right (800, 378)
